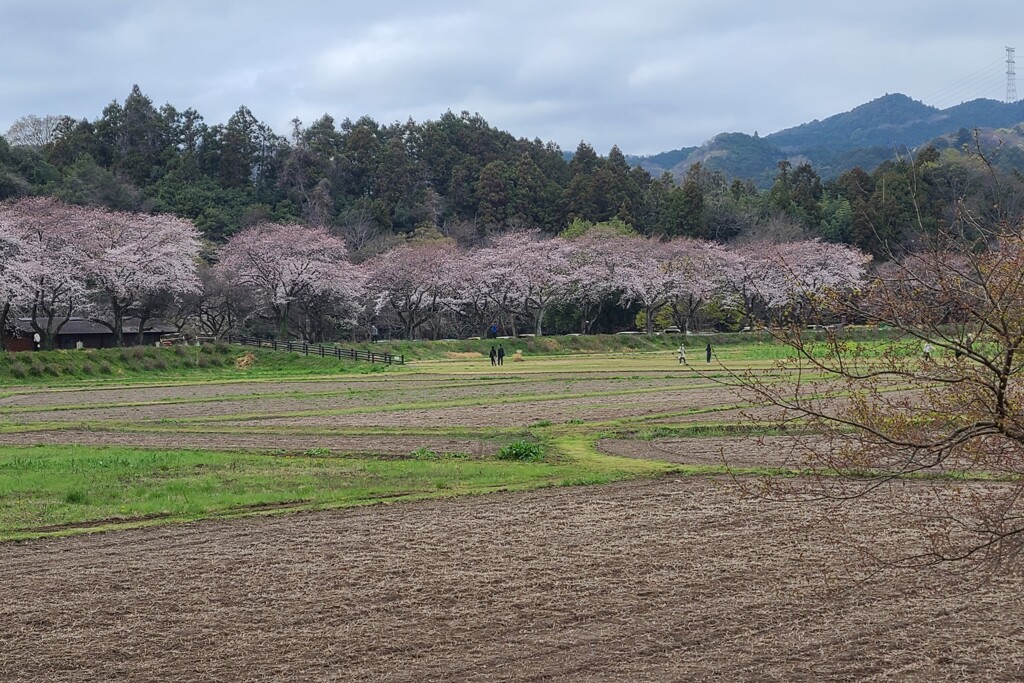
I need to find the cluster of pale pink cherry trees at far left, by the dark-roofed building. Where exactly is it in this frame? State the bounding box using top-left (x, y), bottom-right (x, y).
top-left (0, 198), bottom-right (201, 348)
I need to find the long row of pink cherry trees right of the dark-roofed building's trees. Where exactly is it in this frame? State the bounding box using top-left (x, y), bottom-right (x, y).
top-left (195, 223), bottom-right (869, 340)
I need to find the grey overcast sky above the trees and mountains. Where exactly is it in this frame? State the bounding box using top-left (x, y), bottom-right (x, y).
top-left (0, 0), bottom-right (1024, 155)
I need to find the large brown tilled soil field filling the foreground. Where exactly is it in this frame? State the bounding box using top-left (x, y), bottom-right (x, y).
top-left (0, 478), bottom-right (1024, 683)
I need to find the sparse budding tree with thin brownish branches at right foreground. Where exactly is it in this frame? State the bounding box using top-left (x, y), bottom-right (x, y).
top-left (739, 205), bottom-right (1024, 566)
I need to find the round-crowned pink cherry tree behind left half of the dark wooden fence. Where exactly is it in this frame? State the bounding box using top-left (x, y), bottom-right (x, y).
top-left (217, 222), bottom-right (362, 339)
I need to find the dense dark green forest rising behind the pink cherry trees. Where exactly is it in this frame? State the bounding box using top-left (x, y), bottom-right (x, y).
top-left (0, 86), bottom-right (1021, 260)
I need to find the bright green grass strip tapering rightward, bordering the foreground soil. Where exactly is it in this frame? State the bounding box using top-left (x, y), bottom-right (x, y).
top-left (0, 439), bottom-right (665, 541)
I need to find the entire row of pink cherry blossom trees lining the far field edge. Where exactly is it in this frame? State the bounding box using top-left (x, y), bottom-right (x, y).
top-left (0, 199), bottom-right (868, 347)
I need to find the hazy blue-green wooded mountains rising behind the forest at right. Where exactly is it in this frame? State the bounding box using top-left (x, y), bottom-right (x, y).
top-left (627, 93), bottom-right (1024, 187)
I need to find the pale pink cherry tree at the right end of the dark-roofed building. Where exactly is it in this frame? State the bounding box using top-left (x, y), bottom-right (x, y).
top-left (78, 209), bottom-right (200, 346)
